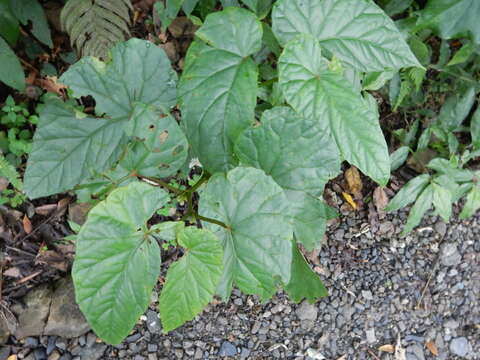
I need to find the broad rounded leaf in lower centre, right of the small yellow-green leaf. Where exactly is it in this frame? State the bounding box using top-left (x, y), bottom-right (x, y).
top-left (199, 167), bottom-right (293, 300)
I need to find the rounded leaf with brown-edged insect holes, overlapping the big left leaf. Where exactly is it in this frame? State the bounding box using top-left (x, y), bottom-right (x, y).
top-left (120, 105), bottom-right (188, 178)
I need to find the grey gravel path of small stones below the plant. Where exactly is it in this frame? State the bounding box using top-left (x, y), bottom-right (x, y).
top-left (0, 207), bottom-right (480, 360)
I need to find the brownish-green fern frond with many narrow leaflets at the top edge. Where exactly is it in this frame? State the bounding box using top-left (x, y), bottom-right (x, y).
top-left (60, 0), bottom-right (132, 58)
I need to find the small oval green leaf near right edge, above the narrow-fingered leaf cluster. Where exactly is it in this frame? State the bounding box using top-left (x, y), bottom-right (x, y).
top-left (438, 86), bottom-right (475, 131)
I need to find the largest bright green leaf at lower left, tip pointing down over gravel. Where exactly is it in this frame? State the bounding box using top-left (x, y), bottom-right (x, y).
top-left (72, 182), bottom-right (168, 344)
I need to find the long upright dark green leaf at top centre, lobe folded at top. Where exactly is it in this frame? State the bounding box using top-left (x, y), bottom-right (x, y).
top-left (179, 7), bottom-right (262, 173)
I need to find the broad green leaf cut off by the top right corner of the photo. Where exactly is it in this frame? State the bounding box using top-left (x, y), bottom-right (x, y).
top-left (418, 0), bottom-right (480, 44)
